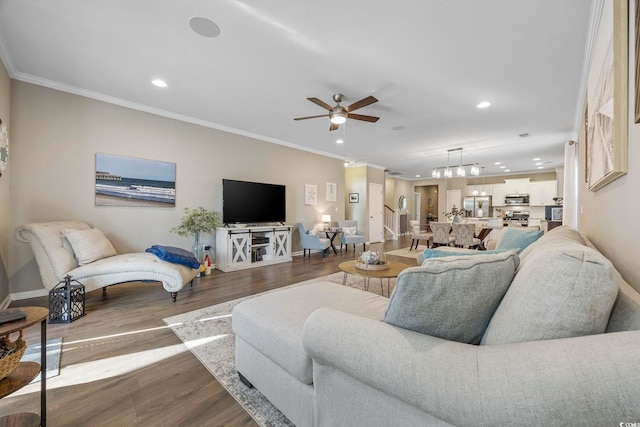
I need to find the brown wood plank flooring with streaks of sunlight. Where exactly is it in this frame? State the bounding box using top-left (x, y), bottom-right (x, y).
top-left (0, 236), bottom-right (411, 427)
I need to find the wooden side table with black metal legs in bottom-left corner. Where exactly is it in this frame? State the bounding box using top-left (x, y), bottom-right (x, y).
top-left (0, 307), bottom-right (49, 427)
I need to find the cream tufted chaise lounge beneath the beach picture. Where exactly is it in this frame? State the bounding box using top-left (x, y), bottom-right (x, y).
top-left (15, 221), bottom-right (198, 302)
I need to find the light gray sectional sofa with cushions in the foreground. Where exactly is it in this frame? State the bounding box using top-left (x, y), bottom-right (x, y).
top-left (233, 227), bottom-right (640, 427)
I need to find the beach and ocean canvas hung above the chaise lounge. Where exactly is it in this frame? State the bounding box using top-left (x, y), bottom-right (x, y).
top-left (96, 153), bottom-right (176, 207)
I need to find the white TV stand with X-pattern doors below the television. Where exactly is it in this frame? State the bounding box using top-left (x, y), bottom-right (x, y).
top-left (216, 225), bottom-right (291, 272)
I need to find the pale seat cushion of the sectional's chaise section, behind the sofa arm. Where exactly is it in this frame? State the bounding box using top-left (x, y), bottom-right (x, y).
top-left (232, 281), bottom-right (389, 384)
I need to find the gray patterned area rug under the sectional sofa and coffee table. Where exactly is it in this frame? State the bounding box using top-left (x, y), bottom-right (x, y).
top-left (163, 273), bottom-right (395, 427)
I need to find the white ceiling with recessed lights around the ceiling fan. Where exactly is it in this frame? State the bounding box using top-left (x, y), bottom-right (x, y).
top-left (0, 0), bottom-right (597, 179)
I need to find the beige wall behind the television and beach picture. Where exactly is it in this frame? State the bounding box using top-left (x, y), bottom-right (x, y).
top-left (8, 80), bottom-right (345, 294)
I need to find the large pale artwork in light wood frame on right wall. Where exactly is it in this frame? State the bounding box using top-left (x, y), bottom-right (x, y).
top-left (586, 0), bottom-right (629, 191)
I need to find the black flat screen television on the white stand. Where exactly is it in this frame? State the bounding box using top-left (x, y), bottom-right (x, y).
top-left (222, 179), bottom-right (287, 224)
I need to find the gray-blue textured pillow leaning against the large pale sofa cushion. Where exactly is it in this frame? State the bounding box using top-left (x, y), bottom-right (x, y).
top-left (383, 251), bottom-right (519, 344)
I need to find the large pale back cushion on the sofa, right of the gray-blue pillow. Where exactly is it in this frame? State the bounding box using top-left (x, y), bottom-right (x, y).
top-left (481, 239), bottom-right (618, 345)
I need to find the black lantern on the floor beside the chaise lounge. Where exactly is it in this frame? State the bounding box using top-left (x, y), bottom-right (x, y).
top-left (49, 275), bottom-right (84, 323)
